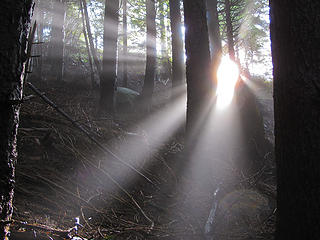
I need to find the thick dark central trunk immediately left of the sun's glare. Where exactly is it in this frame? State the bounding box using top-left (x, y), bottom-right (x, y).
top-left (183, 0), bottom-right (212, 133)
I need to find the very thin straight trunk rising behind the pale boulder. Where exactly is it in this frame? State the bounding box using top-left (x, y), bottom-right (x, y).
top-left (122, 0), bottom-right (128, 87)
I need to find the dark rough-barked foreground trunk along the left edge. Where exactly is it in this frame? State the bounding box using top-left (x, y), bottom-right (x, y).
top-left (0, 0), bottom-right (33, 239)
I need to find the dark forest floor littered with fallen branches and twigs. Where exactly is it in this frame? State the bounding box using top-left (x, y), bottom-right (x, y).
top-left (13, 78), bottom-right (276, 240)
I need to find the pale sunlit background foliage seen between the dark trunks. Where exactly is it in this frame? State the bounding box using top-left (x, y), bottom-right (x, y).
top-left (33, 0), bottom-right (272, 89)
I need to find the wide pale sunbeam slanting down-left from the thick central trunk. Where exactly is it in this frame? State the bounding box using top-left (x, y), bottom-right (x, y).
top-left (95, 88), bottom-right (186, 191)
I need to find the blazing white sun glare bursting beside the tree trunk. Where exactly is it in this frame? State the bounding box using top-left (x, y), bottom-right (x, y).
top-left (217, 57), bottom-right (239, 109)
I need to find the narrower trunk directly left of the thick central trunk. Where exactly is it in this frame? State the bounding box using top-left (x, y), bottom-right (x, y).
top-left (169, 0), bottom-right (184, 88)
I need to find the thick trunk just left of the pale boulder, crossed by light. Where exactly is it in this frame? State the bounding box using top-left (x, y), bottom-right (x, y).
top-left (100, 0), bottom-right (119, 113)
